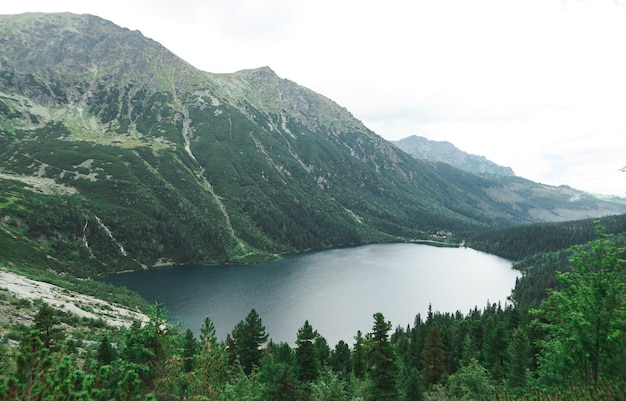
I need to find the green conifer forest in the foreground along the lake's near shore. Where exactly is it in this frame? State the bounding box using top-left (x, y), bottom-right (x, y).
top-left (0, 225), bottom-right (626, 401)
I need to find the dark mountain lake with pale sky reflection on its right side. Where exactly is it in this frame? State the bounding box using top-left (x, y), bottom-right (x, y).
top-left (104, 244), bottom-right (520, 346)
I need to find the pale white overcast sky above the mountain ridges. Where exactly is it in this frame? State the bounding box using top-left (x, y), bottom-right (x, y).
top-left (0, 0), bottom-right (626, 196)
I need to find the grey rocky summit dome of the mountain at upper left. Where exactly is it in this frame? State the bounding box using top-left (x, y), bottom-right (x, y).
top-left (0, 13), bottom-right (199, 106)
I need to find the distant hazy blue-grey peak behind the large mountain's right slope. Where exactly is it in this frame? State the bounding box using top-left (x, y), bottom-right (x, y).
top-left (392, 135), bottom-right (515, 176)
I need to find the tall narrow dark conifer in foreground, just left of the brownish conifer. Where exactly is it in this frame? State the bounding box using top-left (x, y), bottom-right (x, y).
top-left (368, 313), bottom-right (400, 401)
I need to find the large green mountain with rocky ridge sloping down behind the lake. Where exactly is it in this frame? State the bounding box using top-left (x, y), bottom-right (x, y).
top-left (0, 13), bottom-right (626, 276)
